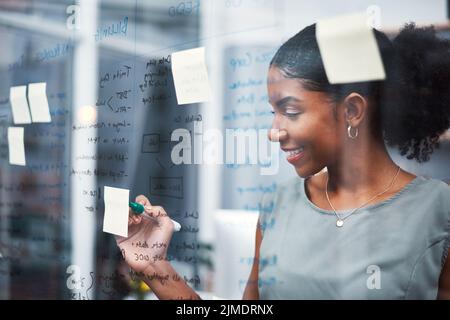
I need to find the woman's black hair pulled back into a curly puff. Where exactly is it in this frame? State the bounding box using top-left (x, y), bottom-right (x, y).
top-left (270, 23), bottom-right (450, 162)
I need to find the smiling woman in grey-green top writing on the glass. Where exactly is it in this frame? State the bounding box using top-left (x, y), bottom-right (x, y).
top-left (118, 24), bottom-right (450, 299)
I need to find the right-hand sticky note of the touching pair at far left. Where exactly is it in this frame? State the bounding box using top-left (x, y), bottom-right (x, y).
top-left (28, 82), bottom-right (52, 122)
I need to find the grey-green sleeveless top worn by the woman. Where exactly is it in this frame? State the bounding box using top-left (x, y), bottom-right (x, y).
top-left (258, 176), bottom-right (450, 299)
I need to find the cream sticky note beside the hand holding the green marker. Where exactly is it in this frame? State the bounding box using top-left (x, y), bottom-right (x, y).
top-left (103, 186), bottom-right (130, 237)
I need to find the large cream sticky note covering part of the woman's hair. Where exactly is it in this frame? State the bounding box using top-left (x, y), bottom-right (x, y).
top-left (316, 13), bottom-right (386, 84)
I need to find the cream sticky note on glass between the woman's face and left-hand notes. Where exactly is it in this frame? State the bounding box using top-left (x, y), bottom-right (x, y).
top-left (171, 47), bottom-right (211, 104)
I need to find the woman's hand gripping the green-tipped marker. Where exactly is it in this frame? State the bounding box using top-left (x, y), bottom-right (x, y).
top-left (116, 195), bottom-right (173, 272)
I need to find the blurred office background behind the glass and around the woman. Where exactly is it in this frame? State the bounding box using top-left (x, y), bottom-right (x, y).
top-left (0, 0), bottom-right (450, 299)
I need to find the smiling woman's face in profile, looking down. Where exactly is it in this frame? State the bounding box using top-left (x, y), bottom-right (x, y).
top-left (268, 67), bottom-right (342, 178)
